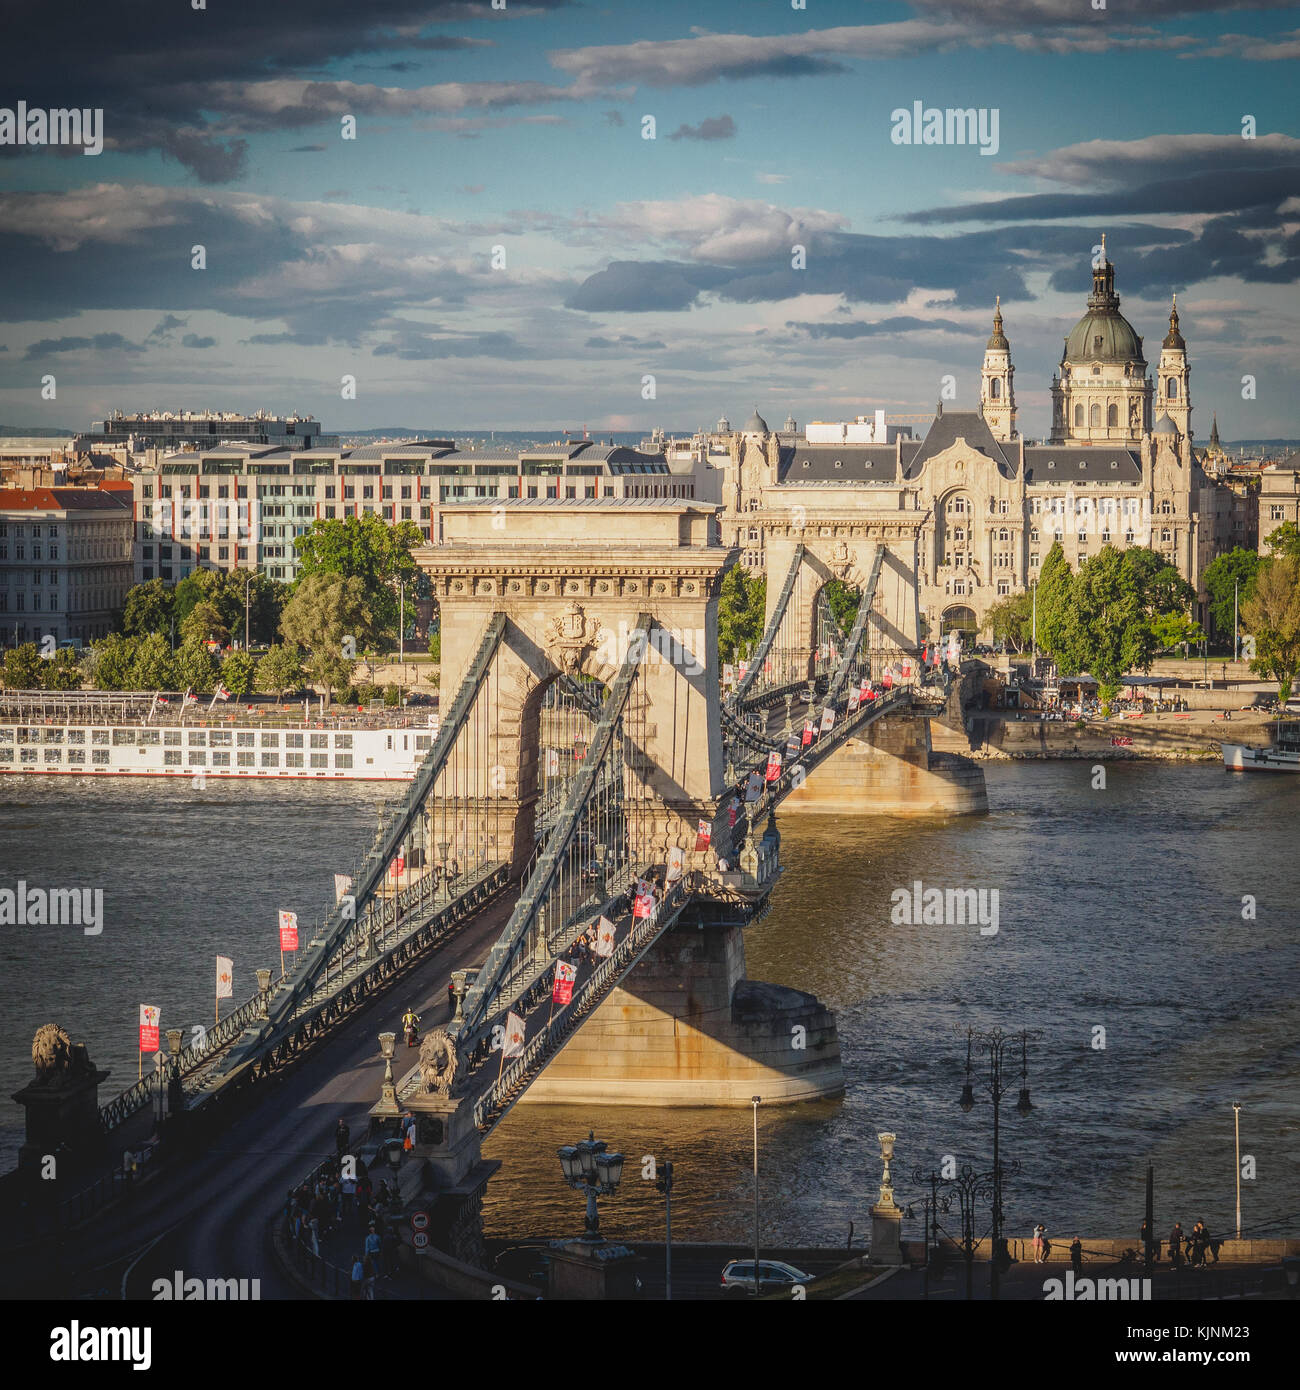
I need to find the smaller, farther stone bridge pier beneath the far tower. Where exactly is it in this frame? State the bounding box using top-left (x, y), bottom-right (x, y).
top-left (781, 717), bottom-right (989, 816)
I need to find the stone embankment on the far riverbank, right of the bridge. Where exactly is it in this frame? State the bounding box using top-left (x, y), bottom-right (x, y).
top-left (930, 709), bottom-right (1272, 762)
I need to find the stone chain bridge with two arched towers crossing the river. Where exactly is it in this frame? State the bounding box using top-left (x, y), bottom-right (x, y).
top-left (58, 499), bottom-right (982, 1262)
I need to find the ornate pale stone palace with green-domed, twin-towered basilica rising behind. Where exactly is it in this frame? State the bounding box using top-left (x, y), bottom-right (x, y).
top-left (722, 250), bottom-right (1214, 634)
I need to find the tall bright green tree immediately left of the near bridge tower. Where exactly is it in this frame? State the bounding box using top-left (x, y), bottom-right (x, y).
top-left (293, 512), bottom-right (425, 642)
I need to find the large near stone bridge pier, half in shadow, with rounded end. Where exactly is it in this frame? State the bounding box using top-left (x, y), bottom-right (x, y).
top-left (520, 909), bottom-right (844, 1106)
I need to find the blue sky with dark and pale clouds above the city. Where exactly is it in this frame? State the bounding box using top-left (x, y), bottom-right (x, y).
top-left (0, 0), bottom-right (1300, 441)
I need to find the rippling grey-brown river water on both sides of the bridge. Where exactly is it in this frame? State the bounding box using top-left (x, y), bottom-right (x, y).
top-left (0, 762), bottom-right (1300, 1245)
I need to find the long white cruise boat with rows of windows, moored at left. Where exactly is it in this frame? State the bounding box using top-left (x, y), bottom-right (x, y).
top-left (0, 691), bottom-right (438, 781)
